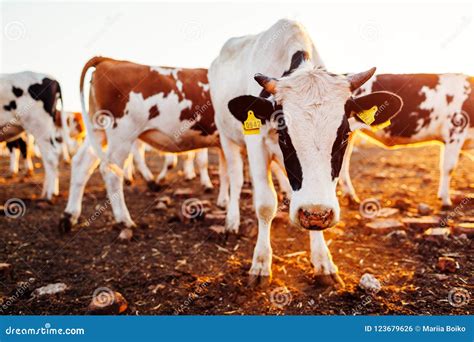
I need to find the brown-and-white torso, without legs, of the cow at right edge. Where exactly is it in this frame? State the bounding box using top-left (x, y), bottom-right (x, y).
top-left (359, 74), bottom-right (474, 146)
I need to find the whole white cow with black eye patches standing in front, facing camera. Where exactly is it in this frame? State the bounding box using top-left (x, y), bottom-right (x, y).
top-left (209, 19), bottom-right (402, 284)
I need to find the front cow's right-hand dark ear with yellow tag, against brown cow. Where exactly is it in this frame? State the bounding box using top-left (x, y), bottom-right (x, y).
top-left (346, 91), bottom-right (403, 126)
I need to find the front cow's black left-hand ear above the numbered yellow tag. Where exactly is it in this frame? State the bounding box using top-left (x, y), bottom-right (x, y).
top-left (227, 95), bottom-right (275, 124)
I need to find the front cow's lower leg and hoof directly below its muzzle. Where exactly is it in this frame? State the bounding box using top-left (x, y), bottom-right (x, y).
top-left (309, 231), bottom-right (344, 286)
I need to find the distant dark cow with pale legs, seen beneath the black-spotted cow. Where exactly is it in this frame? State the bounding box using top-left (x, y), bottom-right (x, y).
top-left (6, 133), bottom-right (34, 177)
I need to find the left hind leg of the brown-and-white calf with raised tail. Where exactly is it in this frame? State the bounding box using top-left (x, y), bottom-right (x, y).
top-left (59, 138), bottom-right (99, 233)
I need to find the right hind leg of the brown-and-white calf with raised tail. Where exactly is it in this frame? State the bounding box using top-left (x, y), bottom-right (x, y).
top-left (100, 135), bottom-right (135, 240)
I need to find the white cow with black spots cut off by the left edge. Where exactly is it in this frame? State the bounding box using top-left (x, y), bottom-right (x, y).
top-left (0, 71), bottom-right (62, 201)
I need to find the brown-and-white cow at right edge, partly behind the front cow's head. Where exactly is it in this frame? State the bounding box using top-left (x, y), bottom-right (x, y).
top-left (340, 74), bottom-right (474, 209)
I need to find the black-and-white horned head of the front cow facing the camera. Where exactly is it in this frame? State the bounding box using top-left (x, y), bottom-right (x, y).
top-left (228, 62), bottom-right (402, 230)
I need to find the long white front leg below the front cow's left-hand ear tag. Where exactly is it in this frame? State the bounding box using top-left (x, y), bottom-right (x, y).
top-left (246, 137), bottom-right (277, 284)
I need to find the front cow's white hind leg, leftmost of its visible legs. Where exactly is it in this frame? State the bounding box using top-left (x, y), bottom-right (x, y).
top-left (220, 135), bottom-right (244, 233)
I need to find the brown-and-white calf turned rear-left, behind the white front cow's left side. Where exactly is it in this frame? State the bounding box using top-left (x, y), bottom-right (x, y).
top-left (60, 57), bottom-right (228, 239)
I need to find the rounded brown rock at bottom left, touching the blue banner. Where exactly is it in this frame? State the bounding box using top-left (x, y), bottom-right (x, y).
top-left (87, 288), bottom-right (128, 315)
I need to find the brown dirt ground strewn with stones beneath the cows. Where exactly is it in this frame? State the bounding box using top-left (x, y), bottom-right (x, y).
top-left (0, 140), bottom-right (474, 315)
